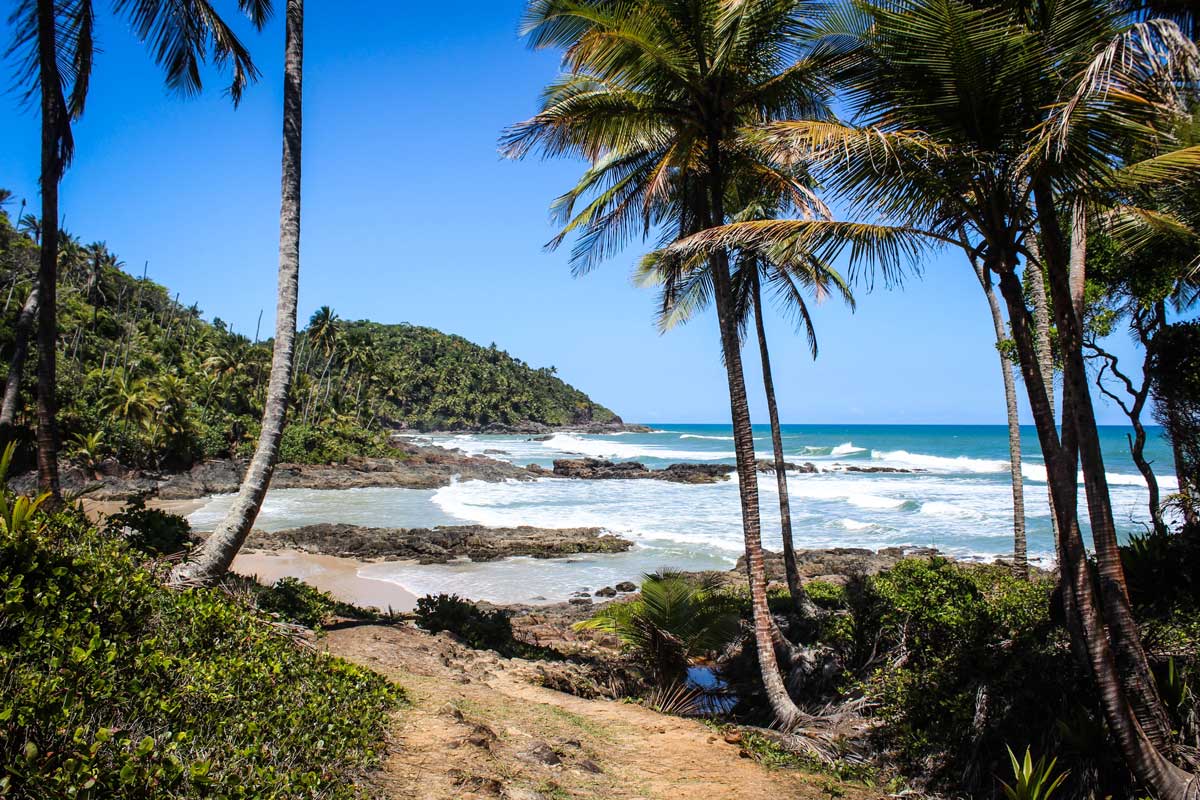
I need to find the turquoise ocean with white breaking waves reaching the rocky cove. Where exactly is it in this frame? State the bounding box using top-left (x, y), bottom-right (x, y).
top-left (190, 425), bottom-right (1176, 603)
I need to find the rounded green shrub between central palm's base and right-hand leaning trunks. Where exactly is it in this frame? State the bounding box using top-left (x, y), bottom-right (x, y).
top-left (860, 559), bottom-right (1080, 790)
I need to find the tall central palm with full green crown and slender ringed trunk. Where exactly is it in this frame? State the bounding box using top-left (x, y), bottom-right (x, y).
top-left (503, 0), bottom-right (823, 726)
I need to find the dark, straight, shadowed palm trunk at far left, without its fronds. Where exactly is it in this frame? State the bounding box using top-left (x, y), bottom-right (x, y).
top-left (37, 0), bottom-right (68, 500)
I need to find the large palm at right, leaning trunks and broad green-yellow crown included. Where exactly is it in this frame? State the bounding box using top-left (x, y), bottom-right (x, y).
top-left (676, 0), bottom-right (1198, 798)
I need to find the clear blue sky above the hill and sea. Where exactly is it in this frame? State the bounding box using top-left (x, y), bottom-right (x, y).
top-left (0, 0), bottom-right (1142, 423)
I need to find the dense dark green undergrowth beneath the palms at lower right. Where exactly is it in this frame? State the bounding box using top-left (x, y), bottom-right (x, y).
top-left (581, 546), bottom-right (1200, 798)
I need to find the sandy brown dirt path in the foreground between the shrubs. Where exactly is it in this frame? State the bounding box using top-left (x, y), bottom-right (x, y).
top-left (324, 626), bottom-right (880, 800)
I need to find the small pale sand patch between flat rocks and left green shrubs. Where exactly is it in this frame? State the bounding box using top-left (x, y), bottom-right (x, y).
top-left (233, 551), bottom-right (416, 612)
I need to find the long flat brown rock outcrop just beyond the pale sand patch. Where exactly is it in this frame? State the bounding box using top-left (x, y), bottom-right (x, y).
top-left (229, 524), bottom-right (632, 564)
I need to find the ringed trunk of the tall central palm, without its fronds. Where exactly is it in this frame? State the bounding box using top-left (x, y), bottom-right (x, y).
top-left (708, 139), bottom-right (803, 730)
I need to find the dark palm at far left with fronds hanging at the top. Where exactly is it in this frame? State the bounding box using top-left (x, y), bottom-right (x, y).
top-left (7, 0), bottom-right (270, 498)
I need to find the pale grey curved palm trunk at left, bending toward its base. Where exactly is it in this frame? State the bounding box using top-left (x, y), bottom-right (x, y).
top-left (172, 0), bottom-right (304, 584)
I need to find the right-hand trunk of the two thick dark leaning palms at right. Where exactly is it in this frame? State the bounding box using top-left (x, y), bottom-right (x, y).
top-left (1034, 179), bottom-right (1171, 752)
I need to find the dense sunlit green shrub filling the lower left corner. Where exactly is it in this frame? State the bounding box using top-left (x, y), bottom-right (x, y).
top-left (0, 513), bottom-right (400, 800)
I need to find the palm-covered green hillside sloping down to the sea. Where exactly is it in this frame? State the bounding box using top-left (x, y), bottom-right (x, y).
top-left (0, 206), bottom-right (616, 468)
